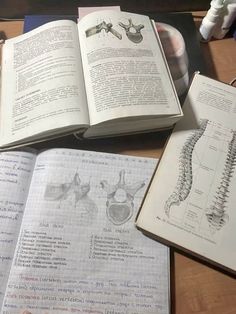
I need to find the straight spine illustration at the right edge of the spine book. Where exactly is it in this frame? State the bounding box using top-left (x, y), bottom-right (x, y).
top-left (206, 131), bottom-right (236, 230)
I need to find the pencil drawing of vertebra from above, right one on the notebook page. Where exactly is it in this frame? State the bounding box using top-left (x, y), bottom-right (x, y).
top-left (101, 170), bottom-right (145, 225)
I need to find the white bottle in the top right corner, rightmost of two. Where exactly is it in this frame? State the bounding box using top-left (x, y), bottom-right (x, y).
top-left (213, 0), bottom-right (236, 39)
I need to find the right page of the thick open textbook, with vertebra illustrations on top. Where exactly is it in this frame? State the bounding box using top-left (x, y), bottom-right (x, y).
top-left (78, 10), bottom-right (180, 125)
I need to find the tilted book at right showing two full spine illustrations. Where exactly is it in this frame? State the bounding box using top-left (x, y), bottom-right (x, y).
top-left (136, 74), bottom-right (236, 273)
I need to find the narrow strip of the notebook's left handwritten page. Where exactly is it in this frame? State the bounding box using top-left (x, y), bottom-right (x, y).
top-left (0, 151), bottom-right (35, 306)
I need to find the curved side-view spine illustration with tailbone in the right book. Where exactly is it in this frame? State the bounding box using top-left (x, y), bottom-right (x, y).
top-left (165, 119), bottom-right (208, 217)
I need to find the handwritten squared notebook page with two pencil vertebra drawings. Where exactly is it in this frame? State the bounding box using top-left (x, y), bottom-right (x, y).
top-left (3, 149), bottom-right (169, 314)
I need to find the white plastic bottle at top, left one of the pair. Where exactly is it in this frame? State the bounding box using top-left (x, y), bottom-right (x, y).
top-left (199, 0), bottom-right (224, 41)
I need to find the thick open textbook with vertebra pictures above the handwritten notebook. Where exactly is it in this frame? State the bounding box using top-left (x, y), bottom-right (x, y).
top-left (0, 10), bottom-right (182, 148)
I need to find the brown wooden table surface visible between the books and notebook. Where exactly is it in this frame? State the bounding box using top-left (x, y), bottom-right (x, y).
top-left (0, 12), bottom-right (236, 314)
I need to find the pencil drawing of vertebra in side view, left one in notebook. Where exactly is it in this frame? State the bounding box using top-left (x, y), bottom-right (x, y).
top-left (44, 172), bottom-right (97, 224)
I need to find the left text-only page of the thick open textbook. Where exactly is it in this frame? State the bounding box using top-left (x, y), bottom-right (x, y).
top-left (0, 21), bottom-right (89, 146)
